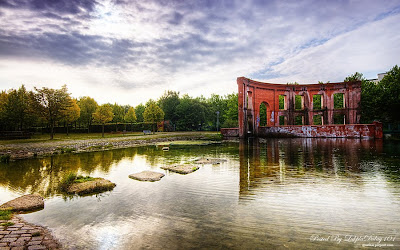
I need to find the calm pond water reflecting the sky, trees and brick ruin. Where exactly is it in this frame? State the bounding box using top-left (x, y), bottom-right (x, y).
top-left (0, 139), bottom-right (400, 249)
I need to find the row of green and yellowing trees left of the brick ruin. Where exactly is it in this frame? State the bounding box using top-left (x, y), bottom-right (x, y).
top-left (0, 85), bottom-right (238, 138)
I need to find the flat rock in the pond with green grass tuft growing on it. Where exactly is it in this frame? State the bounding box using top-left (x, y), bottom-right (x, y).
top-left (66, 178), bottom-right (116, 194)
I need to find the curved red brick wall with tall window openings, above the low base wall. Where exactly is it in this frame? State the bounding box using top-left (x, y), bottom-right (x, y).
top-left (237, 77), bottom-right (361, 137)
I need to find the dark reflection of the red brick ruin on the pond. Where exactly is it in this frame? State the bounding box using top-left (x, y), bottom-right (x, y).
top-left (239, 138), bottom-right (388, 196)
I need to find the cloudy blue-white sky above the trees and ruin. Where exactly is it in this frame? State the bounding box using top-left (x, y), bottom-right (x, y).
top-left (0, 0), bottom-right (400, 106)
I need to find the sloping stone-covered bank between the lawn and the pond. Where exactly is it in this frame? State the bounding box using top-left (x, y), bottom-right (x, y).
top-left (0, 132), bottom-right (219, 160)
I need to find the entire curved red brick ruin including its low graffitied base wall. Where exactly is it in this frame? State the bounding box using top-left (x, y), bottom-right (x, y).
top-left (221, 77), bottom-right (382, 138)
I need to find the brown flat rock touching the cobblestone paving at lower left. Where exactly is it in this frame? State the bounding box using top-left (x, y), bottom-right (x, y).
top-left (0, 194), bottom-right (44, 211)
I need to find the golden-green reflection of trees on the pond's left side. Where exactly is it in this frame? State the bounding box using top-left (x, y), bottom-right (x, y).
top-left (0, 149), bottom-right (136, 197)
